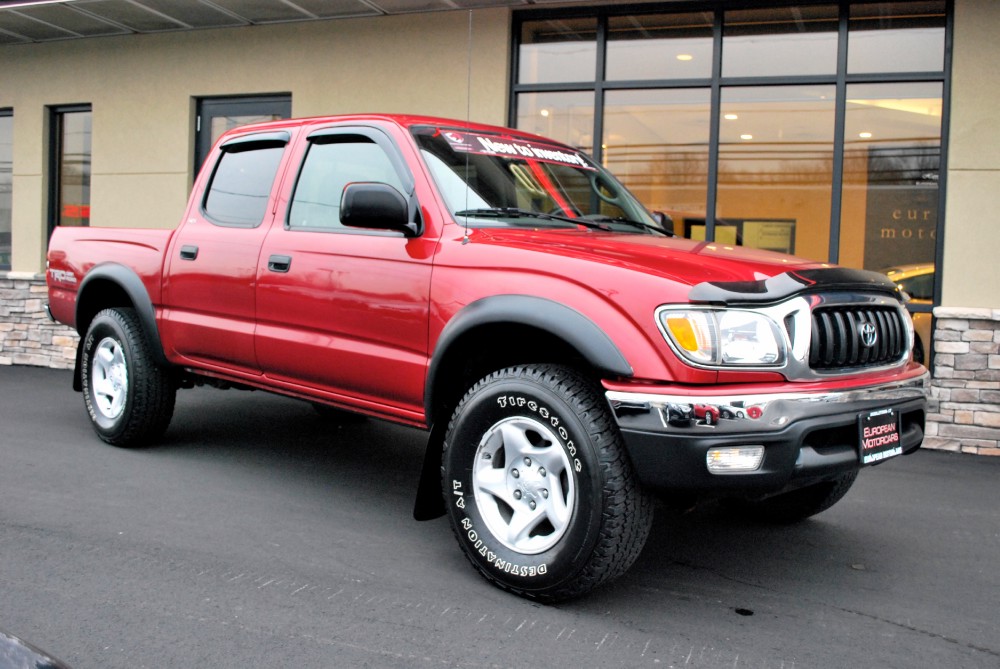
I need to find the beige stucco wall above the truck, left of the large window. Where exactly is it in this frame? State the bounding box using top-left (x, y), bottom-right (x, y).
top-left (0, 9), bottom-right (510, 272)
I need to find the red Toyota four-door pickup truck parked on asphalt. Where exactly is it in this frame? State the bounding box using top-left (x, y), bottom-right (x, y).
top-left (48, 115), bottom-right (928, 601)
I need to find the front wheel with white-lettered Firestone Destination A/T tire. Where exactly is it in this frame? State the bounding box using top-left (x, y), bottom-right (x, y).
top-left (442, 365), bottom-right (652, 603)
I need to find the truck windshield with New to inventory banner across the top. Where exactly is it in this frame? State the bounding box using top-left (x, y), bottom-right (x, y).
top-left (412, 126), bottom-right (666, 234)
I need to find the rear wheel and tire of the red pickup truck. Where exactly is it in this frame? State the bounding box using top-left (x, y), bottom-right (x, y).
top-left (80, 308), bottom-right (177, 447)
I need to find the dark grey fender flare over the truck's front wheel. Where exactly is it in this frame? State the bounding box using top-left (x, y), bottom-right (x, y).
top-left (424, 295), bottom-right (633, 420)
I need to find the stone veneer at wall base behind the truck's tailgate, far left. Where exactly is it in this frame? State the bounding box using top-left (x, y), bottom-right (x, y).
top-left (0, 272), bottom-right (78, 369)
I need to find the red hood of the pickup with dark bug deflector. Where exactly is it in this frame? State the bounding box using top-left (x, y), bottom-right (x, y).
top-left (468, 228), bottom-right (897, 303)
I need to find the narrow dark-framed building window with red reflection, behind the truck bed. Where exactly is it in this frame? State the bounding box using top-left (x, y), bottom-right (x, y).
top-left (49, 105), bottom-right (93, 232)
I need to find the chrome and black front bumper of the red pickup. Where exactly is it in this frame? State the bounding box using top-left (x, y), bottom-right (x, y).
top-left (606, 372), bottom-right (930, 492)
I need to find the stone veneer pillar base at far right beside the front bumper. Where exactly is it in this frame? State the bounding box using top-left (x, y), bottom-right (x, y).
top-left (924, 307), bottom-right (1000, 455)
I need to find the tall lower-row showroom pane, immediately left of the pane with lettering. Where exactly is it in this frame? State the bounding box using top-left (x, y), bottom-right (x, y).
top-left (716, 85), bottom-right (836, 261)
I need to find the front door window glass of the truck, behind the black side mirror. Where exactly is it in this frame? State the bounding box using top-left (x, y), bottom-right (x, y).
top-left (288, 135), bottom-right (405, 230)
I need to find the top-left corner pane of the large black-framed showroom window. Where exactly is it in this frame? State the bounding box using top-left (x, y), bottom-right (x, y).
top-left (517, 19), bottom-right (597, 84)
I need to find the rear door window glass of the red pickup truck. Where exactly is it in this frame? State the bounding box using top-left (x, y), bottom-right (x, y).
top-left (204, 143), bottom-right (285, 228)
